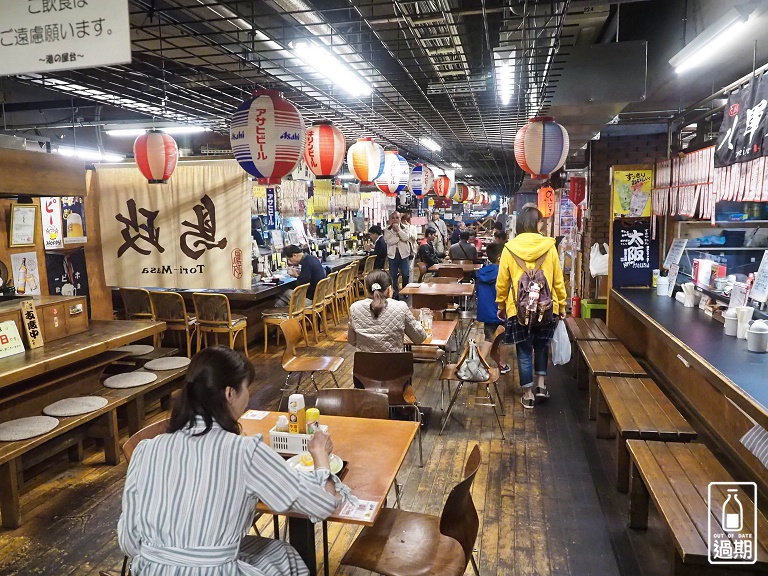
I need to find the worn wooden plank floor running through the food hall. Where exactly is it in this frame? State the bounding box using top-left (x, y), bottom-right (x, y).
top-left (0, 320), bottom-right (670, 576)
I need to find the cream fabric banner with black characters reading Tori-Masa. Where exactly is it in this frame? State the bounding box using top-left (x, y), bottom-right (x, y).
top-left (94, 160), bottom-right (251, 290)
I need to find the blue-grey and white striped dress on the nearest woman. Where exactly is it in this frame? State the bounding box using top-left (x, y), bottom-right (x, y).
top-left (117, 418), bottom-right (337, 576)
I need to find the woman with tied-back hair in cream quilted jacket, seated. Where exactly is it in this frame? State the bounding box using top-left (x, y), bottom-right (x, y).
top-left (347, 270), bottom-right (427, 352)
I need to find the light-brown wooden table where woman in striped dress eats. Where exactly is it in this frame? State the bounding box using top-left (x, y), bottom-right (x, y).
top-left (240, 412), bottom-right (418, 576)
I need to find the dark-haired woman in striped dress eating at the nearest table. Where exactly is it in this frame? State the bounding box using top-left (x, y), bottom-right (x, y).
top-left (117, 346), bottom-right (349, 576)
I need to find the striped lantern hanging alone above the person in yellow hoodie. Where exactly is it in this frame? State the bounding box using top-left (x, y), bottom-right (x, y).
top-left (515, 117), bottom-right (569, 178)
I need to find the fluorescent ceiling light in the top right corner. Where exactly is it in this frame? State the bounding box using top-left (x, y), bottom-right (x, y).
top-left (669, 3), bottom-right (754, 74)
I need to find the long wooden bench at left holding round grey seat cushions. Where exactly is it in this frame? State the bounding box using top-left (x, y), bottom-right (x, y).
top-left (0, 364), bottom-right (187, 528)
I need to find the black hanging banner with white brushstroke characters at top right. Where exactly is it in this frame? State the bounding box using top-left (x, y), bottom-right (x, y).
top-left (715, 78), bottom-right (768, 168)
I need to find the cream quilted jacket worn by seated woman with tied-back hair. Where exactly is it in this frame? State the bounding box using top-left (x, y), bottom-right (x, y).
top-left (347, 298), bottom-right (427, 352)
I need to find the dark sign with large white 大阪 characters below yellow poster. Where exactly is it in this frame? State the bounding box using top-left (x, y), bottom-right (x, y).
top-left (612, 218), bottom-right (659, 288)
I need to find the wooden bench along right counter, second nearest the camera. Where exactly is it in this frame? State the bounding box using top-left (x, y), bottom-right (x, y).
top-left (597, 376), bottom-right (696, 492)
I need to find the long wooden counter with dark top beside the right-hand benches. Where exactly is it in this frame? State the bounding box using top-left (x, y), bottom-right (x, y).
top-left (608, 289), bottom-right (768, 495)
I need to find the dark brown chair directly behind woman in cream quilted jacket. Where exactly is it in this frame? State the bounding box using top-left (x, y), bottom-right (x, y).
top-left (352, 352), bottom-right (424, 466)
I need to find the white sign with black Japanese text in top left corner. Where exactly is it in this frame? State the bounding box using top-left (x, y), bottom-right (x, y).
top-left (0, 0), bottom-right (131, 76)
